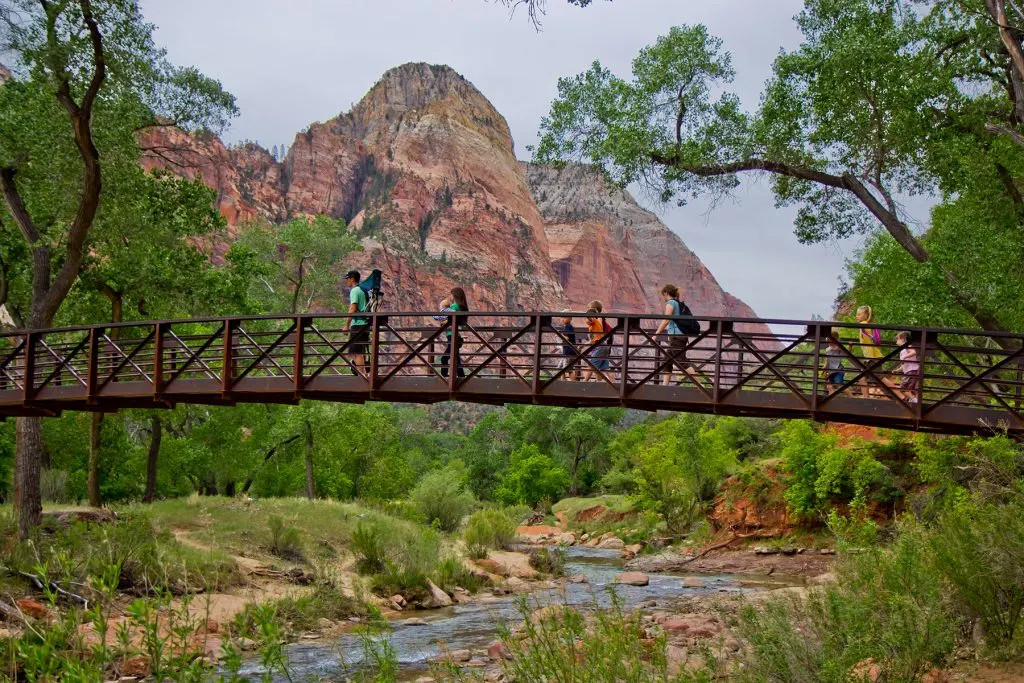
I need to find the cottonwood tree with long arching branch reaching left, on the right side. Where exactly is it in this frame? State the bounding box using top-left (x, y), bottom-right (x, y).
top-left (535, 0), bottom-right (1020, 332)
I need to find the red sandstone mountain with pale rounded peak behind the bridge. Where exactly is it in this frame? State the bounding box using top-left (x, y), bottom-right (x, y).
top-left (144, 63), bottom-right (765, 323)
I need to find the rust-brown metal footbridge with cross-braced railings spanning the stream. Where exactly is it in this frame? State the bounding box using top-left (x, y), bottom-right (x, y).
top-left (0, 312), bottom-right (1024, 434)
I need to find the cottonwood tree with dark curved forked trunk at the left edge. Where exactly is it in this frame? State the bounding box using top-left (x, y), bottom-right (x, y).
top-left (0, 0), bottom-right (236, 536)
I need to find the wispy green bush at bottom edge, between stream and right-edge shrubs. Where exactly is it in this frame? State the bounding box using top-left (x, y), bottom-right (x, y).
top-left (733, 523), bottom-right (963, 683)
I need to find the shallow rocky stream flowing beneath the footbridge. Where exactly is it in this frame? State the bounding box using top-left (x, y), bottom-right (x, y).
top-left (237, 547), bottom-right (775, 681)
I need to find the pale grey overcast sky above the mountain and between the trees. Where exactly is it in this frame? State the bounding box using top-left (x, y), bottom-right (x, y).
top-left (142, 0), bottom-right (868, 318)
